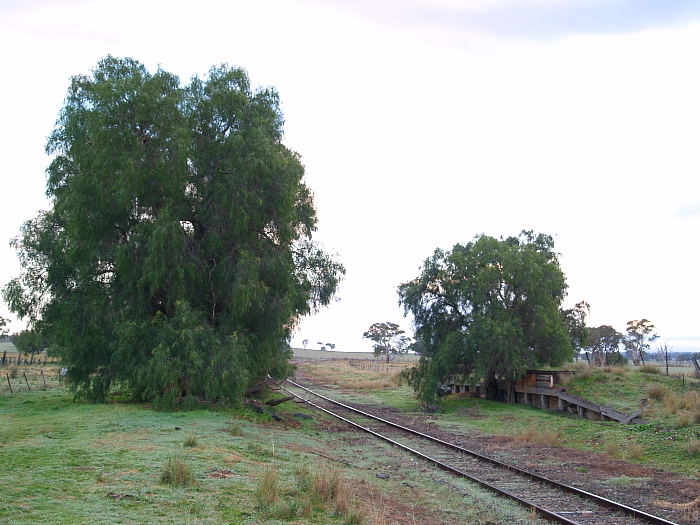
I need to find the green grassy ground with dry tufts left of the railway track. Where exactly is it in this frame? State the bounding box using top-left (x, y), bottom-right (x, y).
top-left (0, 364), bottom-right (535, 525)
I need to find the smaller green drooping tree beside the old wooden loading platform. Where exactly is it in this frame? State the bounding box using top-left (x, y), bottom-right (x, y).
top-left (398, 232), bottom-right (573, 402)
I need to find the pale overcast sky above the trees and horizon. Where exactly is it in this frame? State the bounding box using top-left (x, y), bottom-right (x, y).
top-left (0, 0), bottom-right (700, 351)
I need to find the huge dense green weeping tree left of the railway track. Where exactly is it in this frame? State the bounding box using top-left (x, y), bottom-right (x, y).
top-left (3, 56), bottom-right (344, 403)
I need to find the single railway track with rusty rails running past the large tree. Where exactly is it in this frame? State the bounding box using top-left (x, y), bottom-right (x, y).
top-left (284, 380), bottom-right (676, 525)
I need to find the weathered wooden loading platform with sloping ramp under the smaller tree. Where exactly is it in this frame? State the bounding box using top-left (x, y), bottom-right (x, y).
top-left (447, 370), bottom-right (648, 423)
